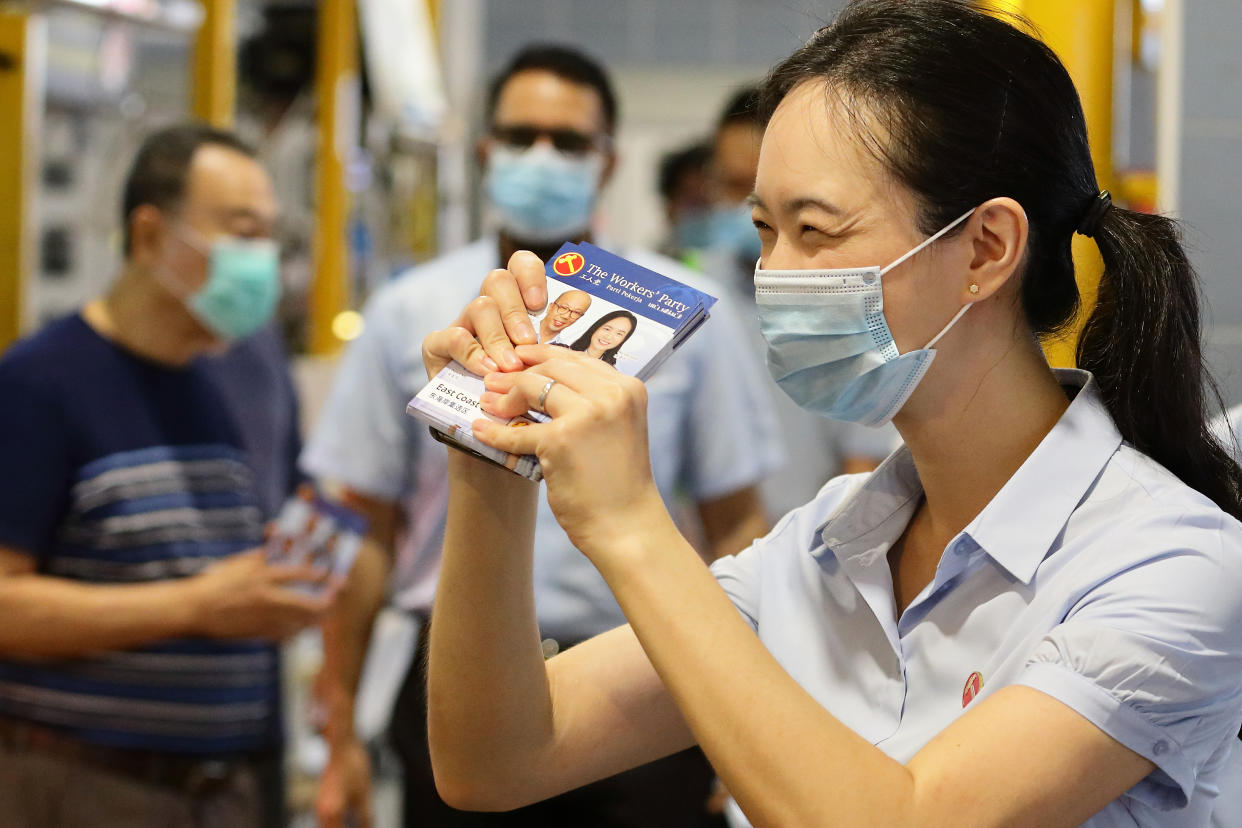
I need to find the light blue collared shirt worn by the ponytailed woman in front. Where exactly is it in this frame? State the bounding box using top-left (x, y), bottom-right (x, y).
top-left (713, 371), bottom-right (1242, 828)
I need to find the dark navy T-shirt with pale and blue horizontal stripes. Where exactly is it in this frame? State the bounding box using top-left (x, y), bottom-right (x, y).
top-left (0, 317), bottom-right (295, 755)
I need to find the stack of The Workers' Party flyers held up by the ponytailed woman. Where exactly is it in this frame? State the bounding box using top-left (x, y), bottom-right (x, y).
top-left (405, 242), bottom-right (715, 480)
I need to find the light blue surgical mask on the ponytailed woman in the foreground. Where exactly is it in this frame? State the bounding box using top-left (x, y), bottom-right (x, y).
top-left (755, 210), bottom-right (974, 426)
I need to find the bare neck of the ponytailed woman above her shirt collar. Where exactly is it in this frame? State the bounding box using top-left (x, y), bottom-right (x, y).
top-left (893, 303), bottom-right (1069, 549)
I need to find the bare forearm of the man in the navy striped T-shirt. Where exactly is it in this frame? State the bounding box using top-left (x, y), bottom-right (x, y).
top-left (0, 574), bottom-right (200, 658)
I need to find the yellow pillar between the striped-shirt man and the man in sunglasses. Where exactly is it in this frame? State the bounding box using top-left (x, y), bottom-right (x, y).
top-left (308, 0), bottom-right (359, 355)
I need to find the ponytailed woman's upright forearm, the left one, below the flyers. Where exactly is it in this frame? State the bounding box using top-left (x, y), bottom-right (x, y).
top-left (427, 452), bottom-right (551, 808)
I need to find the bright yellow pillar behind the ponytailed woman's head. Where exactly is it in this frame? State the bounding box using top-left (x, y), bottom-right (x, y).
top-left (987, 0), bottom-right (1117, 366)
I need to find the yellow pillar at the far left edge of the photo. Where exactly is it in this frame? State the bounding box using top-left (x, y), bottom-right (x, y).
top-left (0, 10), bottom-right (43, 349)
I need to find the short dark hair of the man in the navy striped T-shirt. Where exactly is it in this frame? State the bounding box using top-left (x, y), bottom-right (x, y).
top-left (120, 123), bottom-right (255, 256)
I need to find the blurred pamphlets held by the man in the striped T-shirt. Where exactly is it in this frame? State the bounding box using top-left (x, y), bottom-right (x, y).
top-left (267, 484), bottom-right (368, 595)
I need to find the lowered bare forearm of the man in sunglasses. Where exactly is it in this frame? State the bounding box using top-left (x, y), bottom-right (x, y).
top-left (319, 539), bottom-right (389, 745)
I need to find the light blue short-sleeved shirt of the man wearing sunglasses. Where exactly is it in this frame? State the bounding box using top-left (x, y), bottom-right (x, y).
top-left (301, 238), bottom-right (784, 641)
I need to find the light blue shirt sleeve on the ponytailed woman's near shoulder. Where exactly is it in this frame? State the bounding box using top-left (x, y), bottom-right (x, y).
top-left (1018, 513), bottom-right (1242, 811)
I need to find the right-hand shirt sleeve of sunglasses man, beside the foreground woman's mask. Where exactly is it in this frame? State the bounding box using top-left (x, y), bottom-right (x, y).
top-left (684, 291), bottom-right (785, 500)
